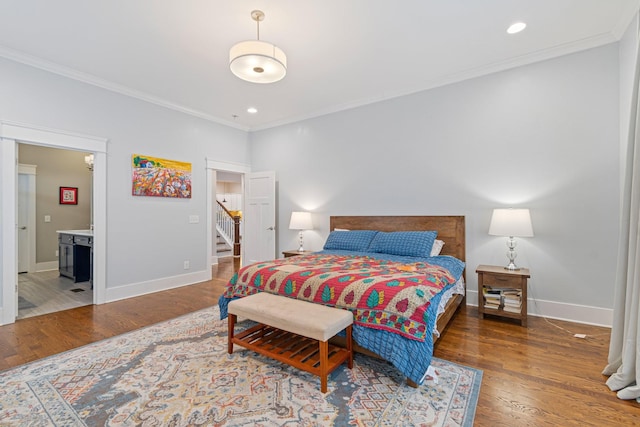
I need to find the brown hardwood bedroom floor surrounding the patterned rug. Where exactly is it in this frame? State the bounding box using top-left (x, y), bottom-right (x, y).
top-left (0, 258), bottom-right (640, 426)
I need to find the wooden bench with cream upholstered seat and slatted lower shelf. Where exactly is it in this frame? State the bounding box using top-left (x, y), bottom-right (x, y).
top-left (228, 292), bottom-right (353, 393)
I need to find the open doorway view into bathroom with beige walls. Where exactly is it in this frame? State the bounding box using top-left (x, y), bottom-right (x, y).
top-left (17, 143), bottom-right (93, 319)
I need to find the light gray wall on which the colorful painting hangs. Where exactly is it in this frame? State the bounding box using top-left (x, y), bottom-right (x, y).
top-left (0, 59), bottom-right (249, 310)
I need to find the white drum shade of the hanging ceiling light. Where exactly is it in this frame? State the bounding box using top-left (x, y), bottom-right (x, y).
top-left (229, 40), bottom-right (287, 83)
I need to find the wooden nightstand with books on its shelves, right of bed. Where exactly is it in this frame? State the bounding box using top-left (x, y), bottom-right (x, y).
top-left (476, 265), bottom-right (531, 326)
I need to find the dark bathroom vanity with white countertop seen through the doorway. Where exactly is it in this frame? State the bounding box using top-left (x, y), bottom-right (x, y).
top-left (57, 230), bottom-right (93, 282)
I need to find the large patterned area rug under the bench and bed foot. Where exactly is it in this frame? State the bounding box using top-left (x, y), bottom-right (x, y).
top-left (0, 307), bottom-right (482, 427)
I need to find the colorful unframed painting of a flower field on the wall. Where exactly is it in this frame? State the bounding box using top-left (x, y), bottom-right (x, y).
top-left (131, 154), bottom-right (191, 199)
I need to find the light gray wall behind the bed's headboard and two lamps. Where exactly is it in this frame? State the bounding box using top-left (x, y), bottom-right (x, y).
top-left (251, 44), bottom-right (620, 324)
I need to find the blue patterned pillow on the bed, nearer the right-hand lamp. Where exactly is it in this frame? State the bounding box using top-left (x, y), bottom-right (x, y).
top-left (368, 231), bottom-right (438, 258)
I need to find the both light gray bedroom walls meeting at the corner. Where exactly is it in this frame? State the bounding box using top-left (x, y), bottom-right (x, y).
top-left (0, 30), bottom-right (626, 323)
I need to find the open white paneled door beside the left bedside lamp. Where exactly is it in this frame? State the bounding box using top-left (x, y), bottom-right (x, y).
top-left (242, 171), bottom-right (276, 265)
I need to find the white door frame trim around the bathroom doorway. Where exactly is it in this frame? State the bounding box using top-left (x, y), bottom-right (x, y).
top-left (0, 121), bottom-right (108, 325)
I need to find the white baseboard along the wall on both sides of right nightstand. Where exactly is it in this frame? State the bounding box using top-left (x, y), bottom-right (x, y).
top-left (467, 290), bottom-right (613, 328)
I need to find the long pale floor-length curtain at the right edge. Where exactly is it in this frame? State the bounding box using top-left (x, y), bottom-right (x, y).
top-left (602, 25), bottom-right (640, 402)
